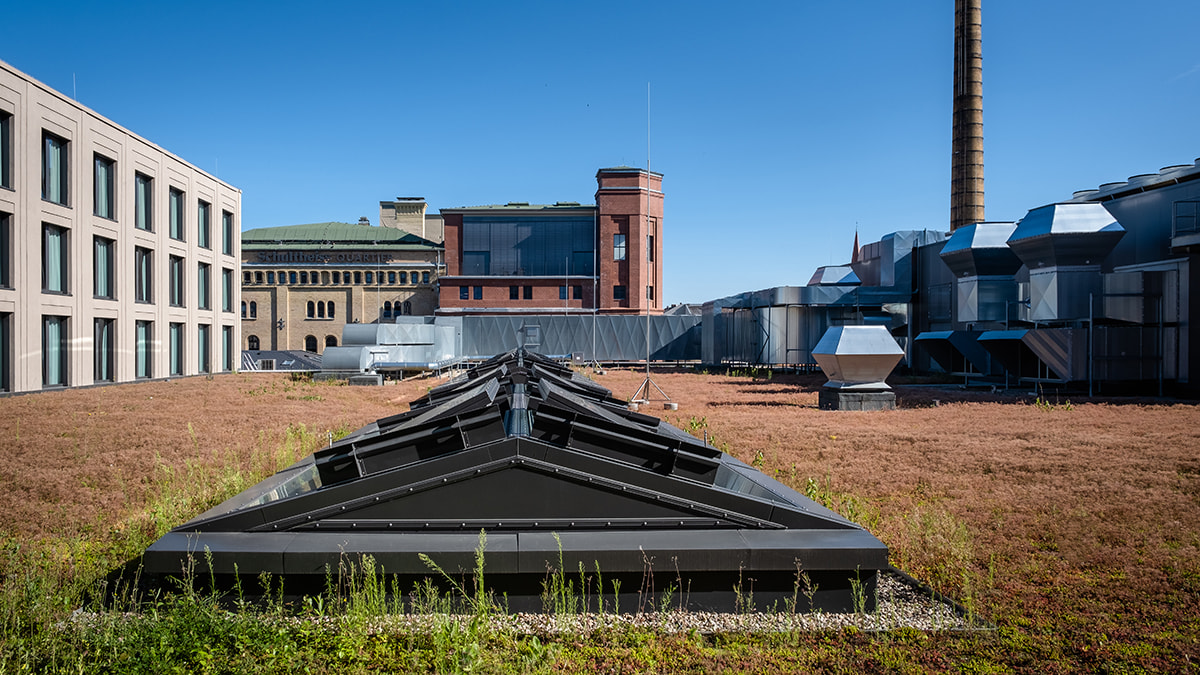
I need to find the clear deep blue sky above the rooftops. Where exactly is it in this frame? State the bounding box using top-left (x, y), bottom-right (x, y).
top-left (0, 0), bottom-right (1200, 304)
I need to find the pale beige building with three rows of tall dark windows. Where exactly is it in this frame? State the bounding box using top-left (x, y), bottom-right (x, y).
top-left (0, 61), bottom-right (241, 392)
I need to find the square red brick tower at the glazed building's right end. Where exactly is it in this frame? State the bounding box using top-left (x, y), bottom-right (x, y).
top-left (596, 167), bottom-right (662, 313)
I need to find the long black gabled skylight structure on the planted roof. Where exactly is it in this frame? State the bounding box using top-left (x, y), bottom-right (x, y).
top-left (142, 350), bottom-right (888, 610)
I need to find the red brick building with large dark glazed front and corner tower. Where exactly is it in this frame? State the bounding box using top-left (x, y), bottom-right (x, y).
top-left (438, 167), bottom-right (664, 315)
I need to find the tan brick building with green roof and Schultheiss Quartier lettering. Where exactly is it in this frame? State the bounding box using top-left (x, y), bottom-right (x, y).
top-left (239, 219), bottom-right (443, 353)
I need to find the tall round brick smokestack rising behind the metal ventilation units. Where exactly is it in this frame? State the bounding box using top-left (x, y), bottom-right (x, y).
top-left (950, 0), bottom-right (985, 232)
